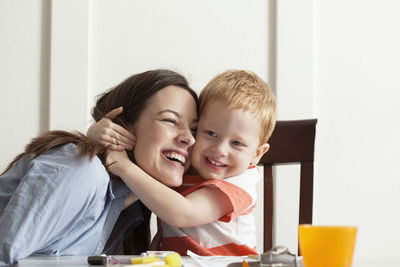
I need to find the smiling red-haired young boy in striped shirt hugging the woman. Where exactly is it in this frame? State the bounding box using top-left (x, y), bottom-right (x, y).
top-left (100, 70), bottom-right (276, 255)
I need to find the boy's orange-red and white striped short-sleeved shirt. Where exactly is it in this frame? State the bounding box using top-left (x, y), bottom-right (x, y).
top-left (159, 166), bottom-right (261, 256)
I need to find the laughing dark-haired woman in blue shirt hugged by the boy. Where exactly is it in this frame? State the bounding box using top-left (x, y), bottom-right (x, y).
top-left (0, 70), bottom-right (198, 266)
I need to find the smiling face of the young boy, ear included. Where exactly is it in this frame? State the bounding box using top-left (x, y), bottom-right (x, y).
top-left (192, 101), bottom-right (269, 180)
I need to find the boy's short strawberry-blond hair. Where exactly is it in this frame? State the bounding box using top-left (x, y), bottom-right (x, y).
top-left (200, 70), bottom-right (276, 144)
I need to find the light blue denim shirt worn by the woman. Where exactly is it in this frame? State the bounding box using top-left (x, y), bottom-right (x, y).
top-left (0, 144), bottom-right (141, 266)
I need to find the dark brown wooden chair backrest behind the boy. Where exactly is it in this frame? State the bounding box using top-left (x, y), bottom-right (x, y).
top-left (259, 119), bottom-right (317, 251)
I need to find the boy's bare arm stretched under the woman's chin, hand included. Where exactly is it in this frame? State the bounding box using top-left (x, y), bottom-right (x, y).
top-left (107, 151), bottom-right (233, 227)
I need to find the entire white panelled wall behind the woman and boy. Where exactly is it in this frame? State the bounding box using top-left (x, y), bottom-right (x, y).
top-left (0, 0), bottom-right (400, 264)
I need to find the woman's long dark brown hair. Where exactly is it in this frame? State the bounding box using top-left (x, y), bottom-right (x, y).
top-left (1, 69), bottom-right (198, 255)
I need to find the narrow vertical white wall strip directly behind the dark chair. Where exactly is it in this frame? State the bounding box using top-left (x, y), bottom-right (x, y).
top-left (273, 0), bottom-right (315, 252)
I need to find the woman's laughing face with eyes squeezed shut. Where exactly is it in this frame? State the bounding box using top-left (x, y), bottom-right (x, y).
top-left (133, 85), bottom-right (198, 186)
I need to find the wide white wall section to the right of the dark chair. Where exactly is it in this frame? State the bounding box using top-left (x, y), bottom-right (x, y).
top-left (314, 0), bottom-right (400, 259)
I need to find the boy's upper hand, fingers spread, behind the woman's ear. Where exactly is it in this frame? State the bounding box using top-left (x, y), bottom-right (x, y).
top-left (86, 107), bottom-right (136, 151)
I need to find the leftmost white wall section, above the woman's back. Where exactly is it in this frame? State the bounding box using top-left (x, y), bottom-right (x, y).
top-left (0, 0), bottom-right (49, 170)
